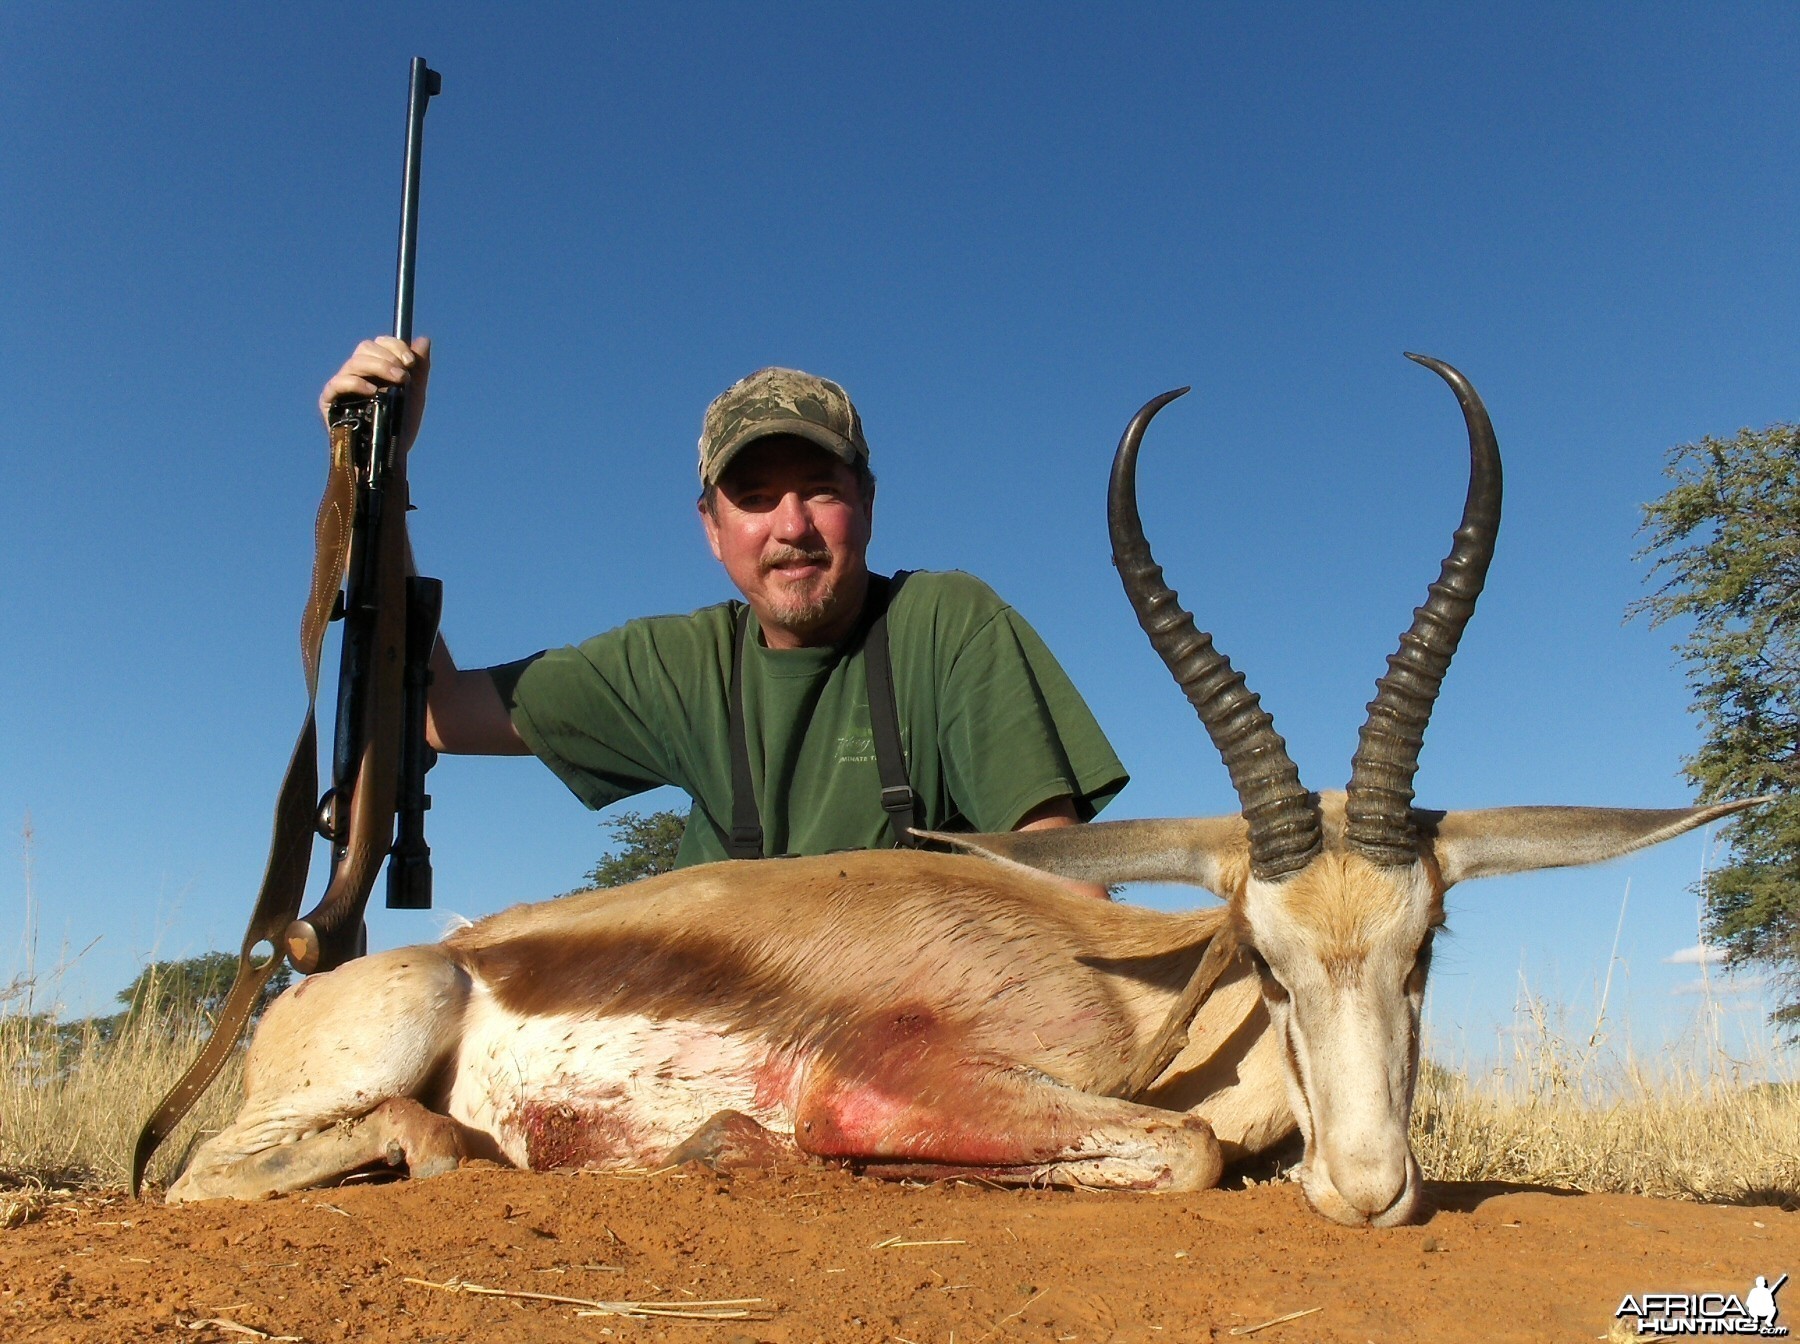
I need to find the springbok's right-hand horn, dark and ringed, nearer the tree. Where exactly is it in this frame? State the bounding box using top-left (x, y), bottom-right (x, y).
top-left (1345, 354), bottom-right (1499, 867)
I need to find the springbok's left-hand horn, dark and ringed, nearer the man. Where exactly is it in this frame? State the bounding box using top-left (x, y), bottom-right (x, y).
top-left (1107, 387), bottom-right (1321, 882)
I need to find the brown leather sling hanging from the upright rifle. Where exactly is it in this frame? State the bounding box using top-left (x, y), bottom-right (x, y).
top-left (131, 415), bottom-right (356, 1198)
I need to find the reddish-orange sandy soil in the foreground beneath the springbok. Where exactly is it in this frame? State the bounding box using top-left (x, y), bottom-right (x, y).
top-left (0, 1166), bottom-right (1800, 1344)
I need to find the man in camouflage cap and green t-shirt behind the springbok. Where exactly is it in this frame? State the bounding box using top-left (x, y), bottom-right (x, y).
top-left (320, 336), bottom-right (1127, 898)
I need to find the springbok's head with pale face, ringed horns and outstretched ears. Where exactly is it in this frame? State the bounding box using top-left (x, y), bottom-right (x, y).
top-left (945, 354), bottom-right (1750, 1227)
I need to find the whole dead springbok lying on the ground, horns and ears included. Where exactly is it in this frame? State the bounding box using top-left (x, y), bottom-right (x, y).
top-left (169, 356), bottom-right (1750, 1225)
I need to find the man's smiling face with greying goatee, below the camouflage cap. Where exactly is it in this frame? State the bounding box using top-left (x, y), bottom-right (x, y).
top-left (700, 437), bottom-right (875, 648)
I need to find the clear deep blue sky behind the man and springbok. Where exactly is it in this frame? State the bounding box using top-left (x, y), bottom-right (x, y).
top-left (0, 2), bottom-right (1800, 1049)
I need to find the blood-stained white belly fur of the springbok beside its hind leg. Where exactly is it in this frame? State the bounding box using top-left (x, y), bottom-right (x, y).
top-left (450, 984), bottom-right (794, 1166)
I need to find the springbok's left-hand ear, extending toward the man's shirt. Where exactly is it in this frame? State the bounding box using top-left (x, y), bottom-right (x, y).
top-left (914, 815), bottom-right (1249, 900)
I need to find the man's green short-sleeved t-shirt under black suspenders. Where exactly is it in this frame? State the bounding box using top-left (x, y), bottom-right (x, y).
top-left (491, 572), bottom-right (1127, 865)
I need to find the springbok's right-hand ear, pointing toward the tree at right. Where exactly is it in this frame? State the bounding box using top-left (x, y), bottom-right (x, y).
top-left (1413, 797), bottom-right (1768, 887)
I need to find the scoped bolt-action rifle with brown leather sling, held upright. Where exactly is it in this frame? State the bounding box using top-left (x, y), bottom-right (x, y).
top-left (131, 56), bottom-right (443, 1196)
